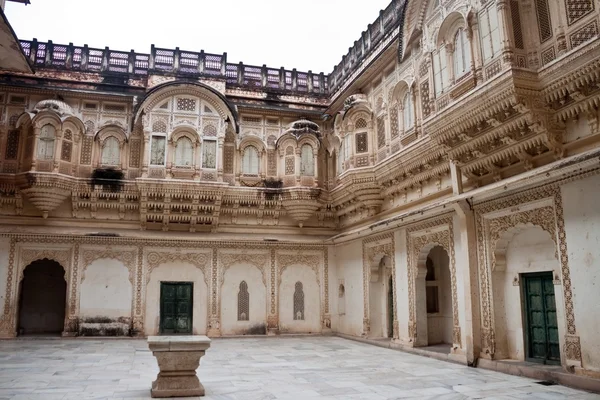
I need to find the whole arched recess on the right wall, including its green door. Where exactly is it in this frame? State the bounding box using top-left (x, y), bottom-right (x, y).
top-left (491, 225), bottom-right (564, 364)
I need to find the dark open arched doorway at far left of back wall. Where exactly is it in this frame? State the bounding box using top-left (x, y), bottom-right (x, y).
top-left (17, 259), bottom-right (67, 335)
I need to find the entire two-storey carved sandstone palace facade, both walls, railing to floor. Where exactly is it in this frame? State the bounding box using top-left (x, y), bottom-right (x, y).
top-left (0, 0), bottom-right (600, 377)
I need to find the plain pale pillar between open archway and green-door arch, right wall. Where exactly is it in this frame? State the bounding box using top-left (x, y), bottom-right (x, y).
top-left (454, 200), bottom-right (481, 365)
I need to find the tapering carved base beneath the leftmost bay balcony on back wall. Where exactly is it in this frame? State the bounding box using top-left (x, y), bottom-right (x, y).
top-left (19, 172), bottom-right (75, 218)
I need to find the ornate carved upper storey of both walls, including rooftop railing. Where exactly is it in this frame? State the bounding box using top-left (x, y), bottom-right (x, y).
top-left (0, 0), bottom-right (600, 235)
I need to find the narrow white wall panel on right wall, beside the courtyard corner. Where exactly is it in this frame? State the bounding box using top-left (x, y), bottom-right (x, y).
top-left (333, 241), bottom-right (364, 336)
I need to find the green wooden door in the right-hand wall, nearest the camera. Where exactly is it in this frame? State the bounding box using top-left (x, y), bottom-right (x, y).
top-left (523, 272), bottom-right (560, 364)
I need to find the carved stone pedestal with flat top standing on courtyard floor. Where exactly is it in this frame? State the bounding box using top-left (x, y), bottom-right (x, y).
top-left (148, 336), bottom-right (210, 398)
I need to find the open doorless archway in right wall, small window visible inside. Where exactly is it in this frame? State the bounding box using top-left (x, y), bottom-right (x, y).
top-left (415, 246), bottom-right (453, 352)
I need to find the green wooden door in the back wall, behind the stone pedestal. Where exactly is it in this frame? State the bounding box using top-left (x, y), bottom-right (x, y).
top-left (160, 282), bottom-right (194, 334)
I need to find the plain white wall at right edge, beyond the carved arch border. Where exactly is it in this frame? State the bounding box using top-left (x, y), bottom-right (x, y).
top-left (561, 175), bottom-right (600, 371)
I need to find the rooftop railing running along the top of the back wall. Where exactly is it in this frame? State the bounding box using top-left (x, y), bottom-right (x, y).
top-left (20, 39), bottom-right (328, 95)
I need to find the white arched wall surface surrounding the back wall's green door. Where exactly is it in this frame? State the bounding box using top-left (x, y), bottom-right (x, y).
top-left (144, 261), bottom-right (208, 336)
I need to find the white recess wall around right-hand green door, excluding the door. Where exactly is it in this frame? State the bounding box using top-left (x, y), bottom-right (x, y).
top-left (492, 226), bottom-right (565, 360)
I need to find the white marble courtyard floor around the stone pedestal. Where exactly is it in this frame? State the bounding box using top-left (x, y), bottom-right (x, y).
top-left (0, 337), bottom-right (600, 400)
